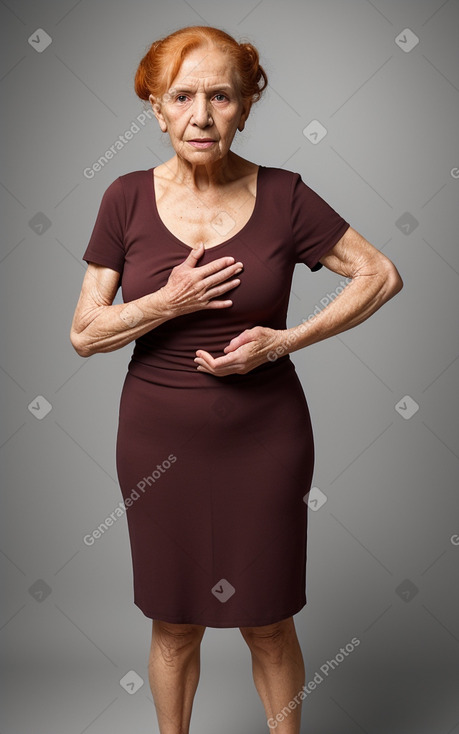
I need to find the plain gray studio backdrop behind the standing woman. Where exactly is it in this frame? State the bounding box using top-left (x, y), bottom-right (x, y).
top-left (0, 0), bottom-right (459, 734)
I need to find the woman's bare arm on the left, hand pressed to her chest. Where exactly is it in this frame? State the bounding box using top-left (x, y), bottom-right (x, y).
top-left (70, 245), bottom-right (242, 357)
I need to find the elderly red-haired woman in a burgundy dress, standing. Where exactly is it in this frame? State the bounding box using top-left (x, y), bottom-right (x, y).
top-left (71, 27), bottom-right (402, 734)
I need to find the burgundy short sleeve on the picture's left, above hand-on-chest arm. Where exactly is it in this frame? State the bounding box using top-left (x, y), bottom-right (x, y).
top-left (82, 178), bottom-right (126, 274)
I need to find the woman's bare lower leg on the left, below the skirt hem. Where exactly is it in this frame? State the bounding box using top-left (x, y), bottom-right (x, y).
top-left (148, 619), bottom-right (206, 734)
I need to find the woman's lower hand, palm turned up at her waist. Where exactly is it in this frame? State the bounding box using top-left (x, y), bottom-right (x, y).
top-left (194, 326), bottom-right (284, 377)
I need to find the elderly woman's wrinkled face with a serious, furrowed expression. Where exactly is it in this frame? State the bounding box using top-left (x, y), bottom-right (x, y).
top-left (150, 47), bottom-right (250, 165)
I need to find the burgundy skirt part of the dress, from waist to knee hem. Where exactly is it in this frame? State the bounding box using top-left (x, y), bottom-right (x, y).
top-left (116, 358), bottom-right (314, 627)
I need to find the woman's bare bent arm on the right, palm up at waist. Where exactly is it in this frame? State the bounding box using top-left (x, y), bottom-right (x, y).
top-left (195, 227), bottom-right (403, 376)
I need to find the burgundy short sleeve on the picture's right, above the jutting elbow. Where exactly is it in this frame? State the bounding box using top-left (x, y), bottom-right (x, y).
top-left (291, 173), bottom-right (349, 270)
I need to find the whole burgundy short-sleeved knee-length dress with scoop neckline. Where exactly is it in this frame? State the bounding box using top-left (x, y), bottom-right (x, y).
top-left (83, 166), bottom-right (349, 627)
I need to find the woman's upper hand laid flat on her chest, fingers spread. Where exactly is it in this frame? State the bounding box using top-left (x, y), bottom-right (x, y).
top-left (156, 242), bottom-right (243, 318)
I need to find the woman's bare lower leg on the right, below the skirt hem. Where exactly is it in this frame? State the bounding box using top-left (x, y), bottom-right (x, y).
top-left (239, 617), bottom-right (305, 734)
